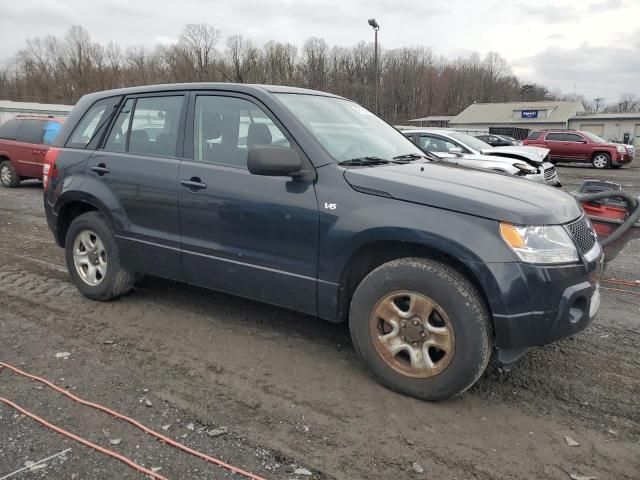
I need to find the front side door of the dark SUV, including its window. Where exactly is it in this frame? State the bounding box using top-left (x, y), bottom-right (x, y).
top-left (179, 95), bottom-right (319, 314)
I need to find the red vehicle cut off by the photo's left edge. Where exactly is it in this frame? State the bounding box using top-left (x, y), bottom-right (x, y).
top-left (0, 116), bottom-right (64, 187)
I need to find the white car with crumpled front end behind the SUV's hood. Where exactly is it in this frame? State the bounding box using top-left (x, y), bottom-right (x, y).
top-left (402, 128), bottom-right (562, 187)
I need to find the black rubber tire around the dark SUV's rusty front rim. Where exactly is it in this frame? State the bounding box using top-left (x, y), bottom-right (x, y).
top-left (349, 258), bottom-right (492, 401)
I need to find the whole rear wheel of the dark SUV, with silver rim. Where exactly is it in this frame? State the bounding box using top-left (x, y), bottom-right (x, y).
top-left (65, 212), bottom-right (137, 301)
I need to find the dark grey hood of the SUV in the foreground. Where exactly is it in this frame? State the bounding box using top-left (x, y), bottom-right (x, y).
top-left (344, 162), bottom-right (582, 225)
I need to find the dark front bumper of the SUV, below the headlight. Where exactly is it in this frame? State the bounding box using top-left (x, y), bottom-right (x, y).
top-left (464, 243), bottom-right (604, 351)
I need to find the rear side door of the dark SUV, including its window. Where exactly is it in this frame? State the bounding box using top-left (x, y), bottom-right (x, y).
top-left (86, 93), bottom-right (186, 279)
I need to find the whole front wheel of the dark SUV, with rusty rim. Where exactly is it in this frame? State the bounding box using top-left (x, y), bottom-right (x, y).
top-left (349, 258), bottom-right (492, 401)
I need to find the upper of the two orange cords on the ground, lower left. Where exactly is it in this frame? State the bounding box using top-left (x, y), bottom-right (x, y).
top-left (0, 362), bottom-right (265, 480)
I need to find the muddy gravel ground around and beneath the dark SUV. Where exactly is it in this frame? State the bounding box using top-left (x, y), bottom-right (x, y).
top-left (0, 161), bottom-right (640, 480)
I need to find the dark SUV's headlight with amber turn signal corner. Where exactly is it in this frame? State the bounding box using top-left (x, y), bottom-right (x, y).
top-left (500, 223), bottom-right (578, 264)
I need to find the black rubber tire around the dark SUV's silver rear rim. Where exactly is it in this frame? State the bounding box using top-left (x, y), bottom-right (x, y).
top-left (65, 212), bottom-right (137, 301)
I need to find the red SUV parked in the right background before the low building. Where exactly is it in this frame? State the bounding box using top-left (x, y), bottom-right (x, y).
top-left (524, 130), bottom-right (633, 168)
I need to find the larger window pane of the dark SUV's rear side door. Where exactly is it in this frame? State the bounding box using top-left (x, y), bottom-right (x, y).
top-left (123, 95), bottom-right (184, 157)
